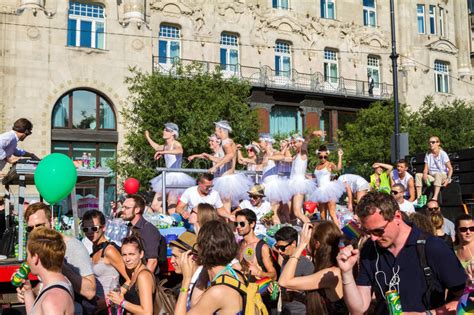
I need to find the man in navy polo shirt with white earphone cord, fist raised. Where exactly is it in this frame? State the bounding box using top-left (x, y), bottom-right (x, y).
top-left (337, 192), bottom-right (467, 314)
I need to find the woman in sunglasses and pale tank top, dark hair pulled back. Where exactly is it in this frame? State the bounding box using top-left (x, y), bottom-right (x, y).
top-left (82, 210), bottom-right (130, 313)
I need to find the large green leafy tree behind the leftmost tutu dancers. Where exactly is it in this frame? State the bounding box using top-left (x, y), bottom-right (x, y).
top-left (114, 64), bottom-right (259, 189)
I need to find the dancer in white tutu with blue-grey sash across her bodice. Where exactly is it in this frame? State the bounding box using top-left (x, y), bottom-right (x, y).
top-left (258, 133), bottom-right (291, 223)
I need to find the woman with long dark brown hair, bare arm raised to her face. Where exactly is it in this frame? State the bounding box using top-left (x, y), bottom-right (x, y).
top-left (278, 221), bottom-right (349, 315)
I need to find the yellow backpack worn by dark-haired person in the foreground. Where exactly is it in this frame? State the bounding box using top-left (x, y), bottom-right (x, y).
top-left (211, 270), bottom-right (268, 315)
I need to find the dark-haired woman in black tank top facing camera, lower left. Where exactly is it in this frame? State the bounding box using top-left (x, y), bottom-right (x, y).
top-left (107, 235), bottom-right (155, 315)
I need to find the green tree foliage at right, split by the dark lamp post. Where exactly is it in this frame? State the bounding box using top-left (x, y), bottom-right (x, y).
top-left (339, 97), bottom-right (474, 176)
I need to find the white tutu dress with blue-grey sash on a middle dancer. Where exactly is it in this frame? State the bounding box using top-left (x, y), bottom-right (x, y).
top-left (262, 160), bottom-right (292, 203)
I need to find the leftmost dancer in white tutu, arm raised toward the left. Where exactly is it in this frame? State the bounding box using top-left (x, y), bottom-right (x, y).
top-left (145, 123), bottom-right (195, 214)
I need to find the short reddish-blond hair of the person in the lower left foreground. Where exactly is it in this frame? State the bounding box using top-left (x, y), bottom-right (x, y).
top-left (27, 227), bottom-right (66, 272)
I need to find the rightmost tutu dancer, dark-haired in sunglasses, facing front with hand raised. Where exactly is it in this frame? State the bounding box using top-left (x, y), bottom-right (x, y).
top-left (309, 145), bottom-right (345, 226)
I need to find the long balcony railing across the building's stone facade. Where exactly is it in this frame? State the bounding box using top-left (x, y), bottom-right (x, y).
top-left (153, 56), bottom-right (392, 99)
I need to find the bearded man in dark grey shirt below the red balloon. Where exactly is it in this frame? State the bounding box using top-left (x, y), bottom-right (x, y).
top-left (122, 195), bottom-right (162, 275)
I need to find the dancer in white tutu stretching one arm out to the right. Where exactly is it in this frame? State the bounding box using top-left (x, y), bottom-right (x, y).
top-left (288, 130), bottom-right (324, 223)
